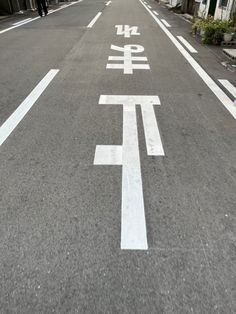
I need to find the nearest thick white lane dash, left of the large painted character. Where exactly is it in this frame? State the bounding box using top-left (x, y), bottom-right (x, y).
top-left (0, 69), bottom-right (59, 146)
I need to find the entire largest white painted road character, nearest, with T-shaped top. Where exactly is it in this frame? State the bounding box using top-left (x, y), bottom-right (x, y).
top-left (94, 95), bottom-right (164, 250)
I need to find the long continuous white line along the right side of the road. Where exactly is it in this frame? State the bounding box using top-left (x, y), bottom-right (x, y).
top-left (139, 0), bottom-right (236, 119)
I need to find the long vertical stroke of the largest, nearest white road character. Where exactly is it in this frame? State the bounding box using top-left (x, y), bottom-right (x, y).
top-left (121, 103), bottom-right (148, 250)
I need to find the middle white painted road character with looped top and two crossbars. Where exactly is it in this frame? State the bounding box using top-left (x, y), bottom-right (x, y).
top-left (106, 45), bottom-right (150, 74)
